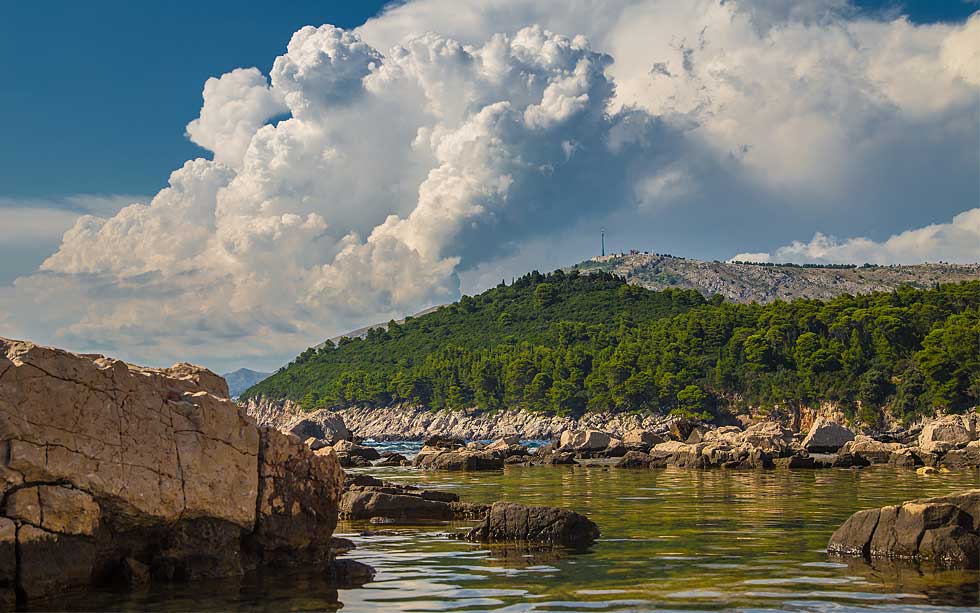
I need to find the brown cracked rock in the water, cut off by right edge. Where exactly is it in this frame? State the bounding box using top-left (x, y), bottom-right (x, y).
top-left (827, 490), bottom-right (980, 569)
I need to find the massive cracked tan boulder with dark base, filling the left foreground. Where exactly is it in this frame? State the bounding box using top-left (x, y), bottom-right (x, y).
top-left (0, 339), bottom-right (343, 608)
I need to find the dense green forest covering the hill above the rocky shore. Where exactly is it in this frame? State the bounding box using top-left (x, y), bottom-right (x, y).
top-left (246, 271), bottom-right (980, 422)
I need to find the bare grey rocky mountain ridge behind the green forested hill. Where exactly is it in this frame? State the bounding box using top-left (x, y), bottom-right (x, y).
top-left (565, 252), bottom-right (980, 304)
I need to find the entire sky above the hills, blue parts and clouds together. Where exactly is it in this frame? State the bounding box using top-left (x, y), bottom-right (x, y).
top-left (0, 0), bottom-right (980, 370)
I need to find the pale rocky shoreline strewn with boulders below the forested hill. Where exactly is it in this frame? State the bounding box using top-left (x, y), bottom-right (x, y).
top-left (256, 405), bottom-right (980, 472)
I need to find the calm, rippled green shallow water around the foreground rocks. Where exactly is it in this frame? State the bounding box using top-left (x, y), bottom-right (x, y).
top-left (47, 467), bottom-right (980, 611)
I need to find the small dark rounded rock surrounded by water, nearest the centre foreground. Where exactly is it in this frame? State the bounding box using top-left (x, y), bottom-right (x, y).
top-left (466, 502), bottom-right (599, 547)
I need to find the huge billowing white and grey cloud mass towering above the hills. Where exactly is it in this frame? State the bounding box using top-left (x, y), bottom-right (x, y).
top-left (0, 0), bottom-right (980, 366)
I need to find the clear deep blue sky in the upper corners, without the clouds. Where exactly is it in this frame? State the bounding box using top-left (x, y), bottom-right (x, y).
top-left (0, 0), bottom-right (977, 198)
